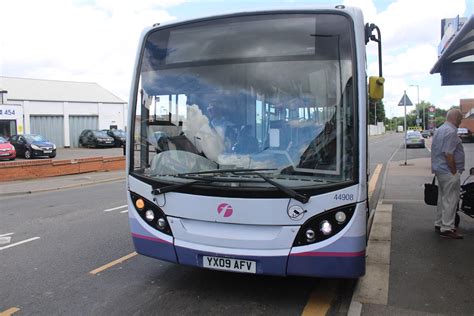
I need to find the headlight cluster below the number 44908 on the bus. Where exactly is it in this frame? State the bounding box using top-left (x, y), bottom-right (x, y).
top-left (293, 204), bottom-right (356, 247)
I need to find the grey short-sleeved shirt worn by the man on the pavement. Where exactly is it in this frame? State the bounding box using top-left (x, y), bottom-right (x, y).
top-left (431, 122), bottom-right (465, 173)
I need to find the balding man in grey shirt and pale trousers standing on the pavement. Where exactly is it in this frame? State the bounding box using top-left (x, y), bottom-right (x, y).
top-left (431, 109), bottom-right (464, 239)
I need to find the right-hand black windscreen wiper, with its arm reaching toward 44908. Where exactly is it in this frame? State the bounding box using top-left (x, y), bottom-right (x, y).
top-left (177, 169), bottom-right (309, 204)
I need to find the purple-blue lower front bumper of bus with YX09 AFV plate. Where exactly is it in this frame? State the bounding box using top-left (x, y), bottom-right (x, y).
top-left (132, 233), bottom-right (365, 278)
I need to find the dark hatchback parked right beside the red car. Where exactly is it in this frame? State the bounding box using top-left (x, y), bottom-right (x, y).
top-left (10, 134), bottom-right (56, 159)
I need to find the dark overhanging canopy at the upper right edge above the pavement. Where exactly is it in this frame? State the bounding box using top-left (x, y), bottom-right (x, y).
top-left (430, 15), bottom-right (474, 86)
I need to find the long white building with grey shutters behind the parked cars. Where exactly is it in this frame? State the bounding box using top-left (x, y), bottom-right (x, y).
top-left (0, 77), bottom-right (127, 147)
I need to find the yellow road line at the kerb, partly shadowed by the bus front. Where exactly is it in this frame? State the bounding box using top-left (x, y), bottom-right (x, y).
top-left (301, 281), bottom-right (336, 316)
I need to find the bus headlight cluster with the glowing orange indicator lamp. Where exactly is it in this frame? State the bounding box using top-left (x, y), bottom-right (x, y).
top-left (130, 192), bottom-right (173, 236)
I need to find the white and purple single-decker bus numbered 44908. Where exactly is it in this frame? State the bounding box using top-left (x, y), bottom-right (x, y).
top-left (127, 6), bottom-right (383, 278)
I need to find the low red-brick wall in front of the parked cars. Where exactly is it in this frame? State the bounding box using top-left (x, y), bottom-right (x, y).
top-left (0, 156), bottom-right (125, 181)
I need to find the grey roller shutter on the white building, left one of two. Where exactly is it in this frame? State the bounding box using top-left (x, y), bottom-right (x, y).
top-left (30, 115), bottom-right (64, 147)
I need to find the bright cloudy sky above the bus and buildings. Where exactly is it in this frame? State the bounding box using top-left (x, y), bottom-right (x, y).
top-left (0, 0), bottom-right (474, 117)
